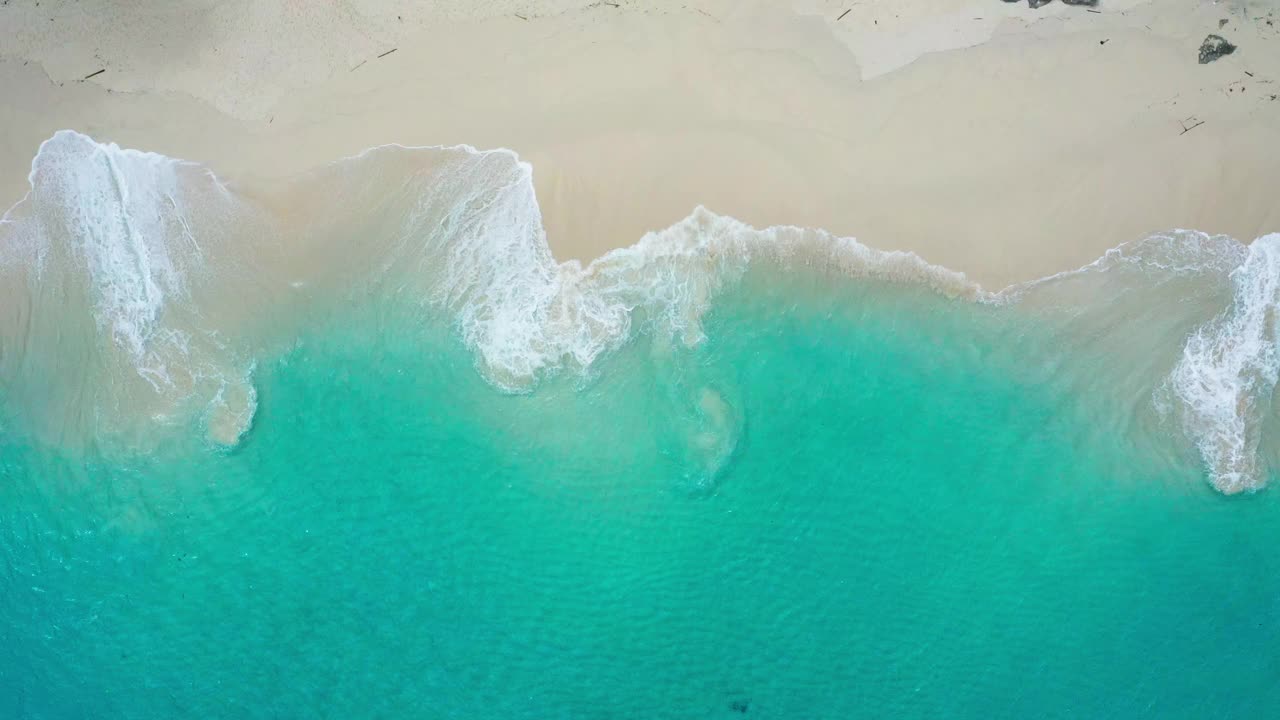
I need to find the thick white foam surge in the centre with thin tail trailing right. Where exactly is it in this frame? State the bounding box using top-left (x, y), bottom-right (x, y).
top-left (378, 146), bottom-right (983, 391)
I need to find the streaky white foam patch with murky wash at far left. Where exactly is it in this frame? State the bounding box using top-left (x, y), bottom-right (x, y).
top-left (0, 131), bottom-right (257, 443)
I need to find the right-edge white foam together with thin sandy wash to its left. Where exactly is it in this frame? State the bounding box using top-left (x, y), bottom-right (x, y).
top-left (998, 229), bottom-right (1280, 493)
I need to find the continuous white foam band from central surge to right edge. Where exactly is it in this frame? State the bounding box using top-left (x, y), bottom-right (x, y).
top-left (391, 149), bottom-right (1280, 492)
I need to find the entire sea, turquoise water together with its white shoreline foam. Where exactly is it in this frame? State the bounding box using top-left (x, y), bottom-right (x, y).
top-left (0, 132), bottom-right (1280, 720)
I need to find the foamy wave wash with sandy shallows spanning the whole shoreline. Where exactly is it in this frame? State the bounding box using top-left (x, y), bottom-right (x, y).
top-left (0, 131), bottom-right (1280, 492)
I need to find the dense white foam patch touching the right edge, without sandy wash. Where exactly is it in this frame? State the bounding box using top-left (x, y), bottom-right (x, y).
top-left (1169, 234), bottom-right (1280, 493)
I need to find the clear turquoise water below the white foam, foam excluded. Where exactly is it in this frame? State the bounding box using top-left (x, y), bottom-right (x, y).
top-left (0, 133), bottom-right (1280, 719)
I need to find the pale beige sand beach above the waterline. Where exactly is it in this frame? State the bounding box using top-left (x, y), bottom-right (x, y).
top-left (0, 0), bottom-right (1280, 287)
